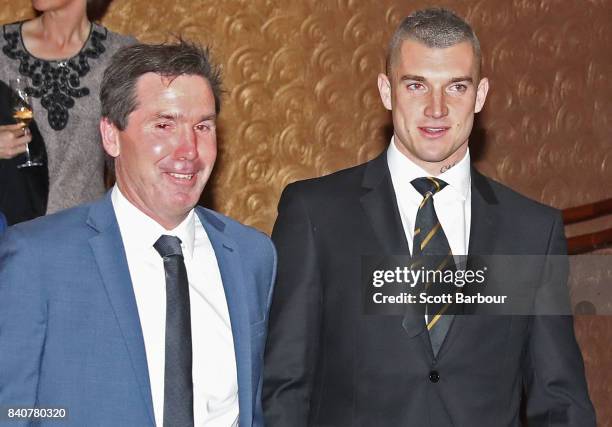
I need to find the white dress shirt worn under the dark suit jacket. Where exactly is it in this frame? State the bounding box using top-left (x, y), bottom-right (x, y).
top-left (387, 138), bottom-right (472, 261)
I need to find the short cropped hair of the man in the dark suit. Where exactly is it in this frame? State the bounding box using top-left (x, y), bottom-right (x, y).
top-left (387, 8), bottom-right (481, 74)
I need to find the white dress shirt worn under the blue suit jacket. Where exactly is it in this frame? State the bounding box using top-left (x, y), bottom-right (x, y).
top-left (111, 186), bottom-right (238, 427)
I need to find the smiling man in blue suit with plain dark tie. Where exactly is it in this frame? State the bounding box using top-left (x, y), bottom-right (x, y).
top-left (0, 42), bottom-right (275, 427)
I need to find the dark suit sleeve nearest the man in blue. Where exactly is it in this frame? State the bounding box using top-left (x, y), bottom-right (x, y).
top-left (263, 186), bottom-right (322, 427)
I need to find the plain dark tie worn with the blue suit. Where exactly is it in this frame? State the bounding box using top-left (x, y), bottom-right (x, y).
top-left (153, 235), bottom-right (193, 427)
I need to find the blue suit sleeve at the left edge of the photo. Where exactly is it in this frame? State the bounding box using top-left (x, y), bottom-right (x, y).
top-left (0, 229), bottom-right (47, 426)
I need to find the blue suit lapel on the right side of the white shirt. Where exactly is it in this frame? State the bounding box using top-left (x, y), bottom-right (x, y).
top-left (196, 208), bottom-right (255, 426)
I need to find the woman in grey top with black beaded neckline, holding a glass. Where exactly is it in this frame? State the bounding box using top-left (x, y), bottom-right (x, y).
top-left (0, 0), bottom-right (135, 221)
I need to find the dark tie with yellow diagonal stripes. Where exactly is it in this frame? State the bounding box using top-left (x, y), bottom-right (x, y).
top-left (411, 177), bottom-right (456, 355)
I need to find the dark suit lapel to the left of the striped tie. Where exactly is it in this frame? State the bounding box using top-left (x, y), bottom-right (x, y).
top-left (361, 151), bottom-right (425, 338)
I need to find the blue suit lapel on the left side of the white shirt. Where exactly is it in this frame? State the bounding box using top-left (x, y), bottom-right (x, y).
top-left (87, 196), bottom-right (155, 424)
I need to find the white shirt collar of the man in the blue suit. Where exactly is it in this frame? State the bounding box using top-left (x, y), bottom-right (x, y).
top-left (111, 185), bottom-right (195, 258)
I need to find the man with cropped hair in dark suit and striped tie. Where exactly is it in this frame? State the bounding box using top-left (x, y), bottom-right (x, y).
top-left (264, 9), bottom-right (595, 427)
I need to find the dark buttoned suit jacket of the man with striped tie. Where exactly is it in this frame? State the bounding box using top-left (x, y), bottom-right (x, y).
top-left (263, 153), bottom-right (595, 427)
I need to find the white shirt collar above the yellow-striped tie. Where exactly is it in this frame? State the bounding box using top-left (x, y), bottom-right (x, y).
top-left (387, 136), bottom-right (471, 200)
